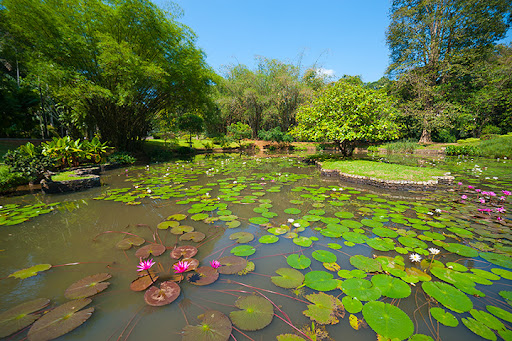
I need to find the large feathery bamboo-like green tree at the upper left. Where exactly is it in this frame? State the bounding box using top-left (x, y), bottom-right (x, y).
top-left (0, 0), bottom-right (213, 149)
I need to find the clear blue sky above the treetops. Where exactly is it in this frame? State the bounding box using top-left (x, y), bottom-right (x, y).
top-left (154, 0), bottom-right (510, 82)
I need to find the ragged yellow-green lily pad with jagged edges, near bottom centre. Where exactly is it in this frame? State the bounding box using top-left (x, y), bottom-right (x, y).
top-left (302, 292), bottom-right (344, 324)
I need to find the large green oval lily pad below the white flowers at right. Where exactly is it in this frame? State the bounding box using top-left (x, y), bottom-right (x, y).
top-left (421, 282), bottom-right (473, 313)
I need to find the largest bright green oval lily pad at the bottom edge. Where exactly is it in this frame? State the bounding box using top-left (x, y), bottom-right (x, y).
top-left (363, 302), bottom-right (414, 340)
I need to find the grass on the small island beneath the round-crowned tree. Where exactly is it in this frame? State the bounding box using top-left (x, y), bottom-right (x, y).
top-left (322, 160), bottom-right (445, 181)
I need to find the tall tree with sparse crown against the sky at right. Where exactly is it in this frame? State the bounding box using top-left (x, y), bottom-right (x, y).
top-left (387, 0), bottom-right (512, 142)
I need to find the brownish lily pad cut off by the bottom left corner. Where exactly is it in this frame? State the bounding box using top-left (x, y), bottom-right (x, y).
top-left (0, 298), bottom-right (50, 338)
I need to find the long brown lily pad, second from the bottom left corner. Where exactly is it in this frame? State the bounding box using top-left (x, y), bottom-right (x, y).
top-left (28, 298), bottom-right (94, 341)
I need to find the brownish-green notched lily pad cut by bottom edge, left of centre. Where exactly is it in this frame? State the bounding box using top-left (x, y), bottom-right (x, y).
top-left (181, 310), bottom-right (233, 341)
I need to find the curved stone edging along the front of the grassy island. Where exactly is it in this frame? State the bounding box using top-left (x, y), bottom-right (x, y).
top-left (315, 161), bottom-right (454, 191)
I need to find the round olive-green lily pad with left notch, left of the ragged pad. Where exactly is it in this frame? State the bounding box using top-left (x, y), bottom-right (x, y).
top-left (229, 296), bottom-right (274, 331)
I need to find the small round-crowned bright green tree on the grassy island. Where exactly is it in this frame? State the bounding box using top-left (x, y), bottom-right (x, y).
top-left (290, 80), bottom-right (399, 156)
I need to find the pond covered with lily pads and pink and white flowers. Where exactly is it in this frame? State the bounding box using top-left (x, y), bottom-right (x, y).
top-left (0, 154), bottom-right (512, 341)
